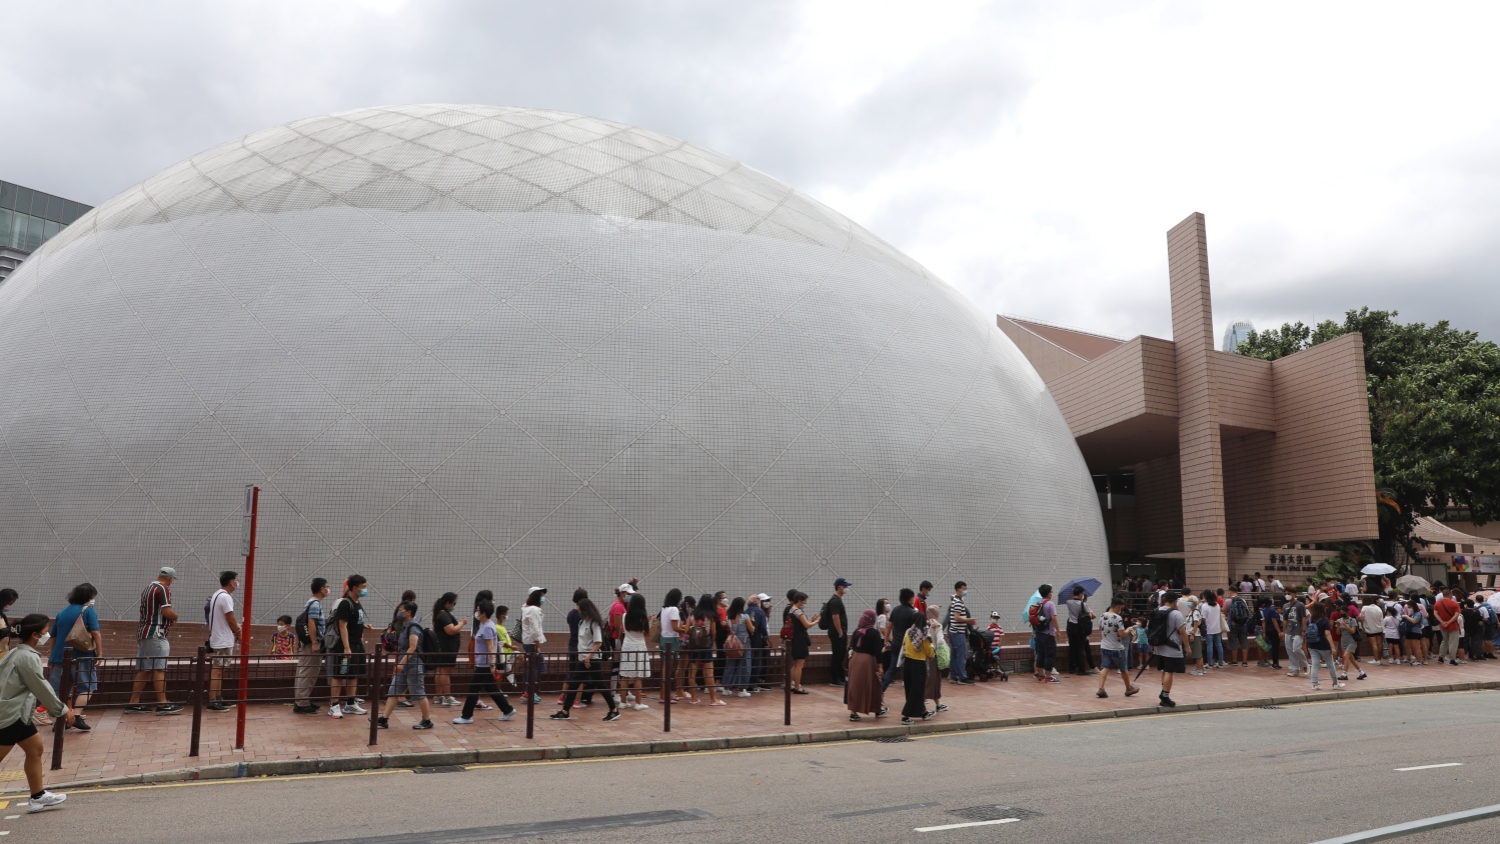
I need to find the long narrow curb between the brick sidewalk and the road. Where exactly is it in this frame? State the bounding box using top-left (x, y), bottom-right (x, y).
top-left (32, 681), bottom-right (1500, 790)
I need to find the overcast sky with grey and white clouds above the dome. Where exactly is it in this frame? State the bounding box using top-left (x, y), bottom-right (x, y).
top-left (0, 0), bottom-right (1500, 339)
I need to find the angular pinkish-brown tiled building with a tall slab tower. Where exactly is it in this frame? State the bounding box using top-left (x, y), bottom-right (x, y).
top-left (998, 213), bottom-right (1379, 589)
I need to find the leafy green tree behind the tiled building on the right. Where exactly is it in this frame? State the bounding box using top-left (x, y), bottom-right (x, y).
top-left (1239, 307), bottom-right (1500, 555)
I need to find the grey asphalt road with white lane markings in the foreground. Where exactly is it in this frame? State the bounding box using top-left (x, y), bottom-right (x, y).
top-left (11, 691), bottom-right (1500, 844)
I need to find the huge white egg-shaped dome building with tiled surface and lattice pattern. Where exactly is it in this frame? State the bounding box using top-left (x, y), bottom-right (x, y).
top-left (0, 105), bottom-right (1109, 625)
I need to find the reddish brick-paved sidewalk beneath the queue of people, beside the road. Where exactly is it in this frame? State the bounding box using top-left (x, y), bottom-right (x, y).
top-left (0, 661), bottom-right (1500, 792)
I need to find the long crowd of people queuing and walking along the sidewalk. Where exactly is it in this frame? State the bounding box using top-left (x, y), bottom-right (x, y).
top-left (0, 567), bottom-right (1500, 811)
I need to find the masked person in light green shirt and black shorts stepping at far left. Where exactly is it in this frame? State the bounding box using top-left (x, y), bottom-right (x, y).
top-left (0, 613), bottom-right (74, 813)
